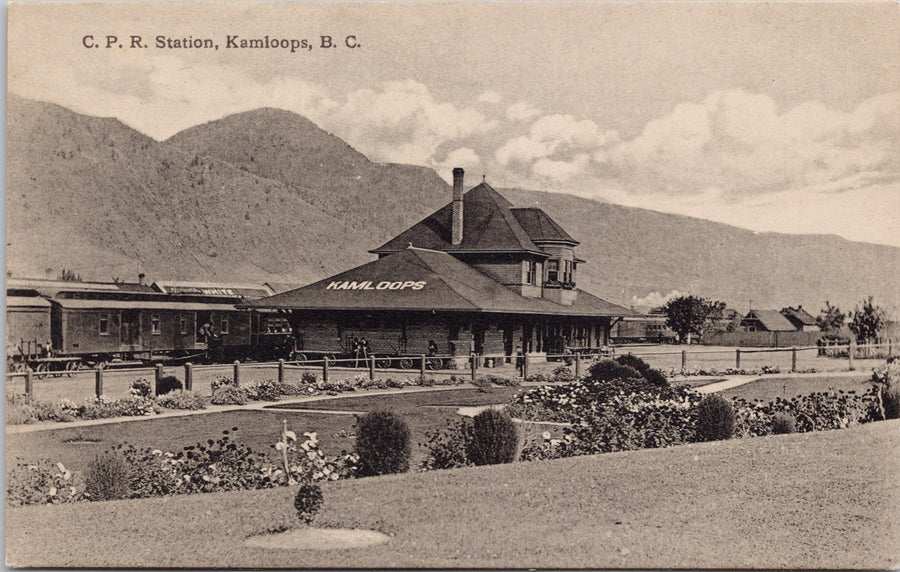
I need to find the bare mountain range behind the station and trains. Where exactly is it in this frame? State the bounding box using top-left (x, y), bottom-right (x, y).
top-left (7, 96), bottom-right (900, 314)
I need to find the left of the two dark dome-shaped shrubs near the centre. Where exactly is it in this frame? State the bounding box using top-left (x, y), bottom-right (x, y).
top-left (356, 411), bottom-right (412, 477)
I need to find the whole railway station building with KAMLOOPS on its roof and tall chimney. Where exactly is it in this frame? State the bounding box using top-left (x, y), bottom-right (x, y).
top-left (242, 169), bottom-right (633, 364)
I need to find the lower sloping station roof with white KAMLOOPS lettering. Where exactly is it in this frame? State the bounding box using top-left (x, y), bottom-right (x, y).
top-left (239, 247), bottom-right (632, 317)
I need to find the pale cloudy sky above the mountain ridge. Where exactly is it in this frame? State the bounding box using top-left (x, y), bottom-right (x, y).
top-left (7, 1), bottom-right (900, 246)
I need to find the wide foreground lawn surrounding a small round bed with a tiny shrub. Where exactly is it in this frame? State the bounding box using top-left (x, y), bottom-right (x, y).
top-left (6, 421), bottom-right (900, 569)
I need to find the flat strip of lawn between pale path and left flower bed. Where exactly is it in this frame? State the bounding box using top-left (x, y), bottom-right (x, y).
top-left (6, 387), bottom-right (519, 471)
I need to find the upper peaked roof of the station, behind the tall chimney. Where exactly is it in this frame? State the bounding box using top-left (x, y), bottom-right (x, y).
top-left (369, 183), bottom-right (548, 255)
